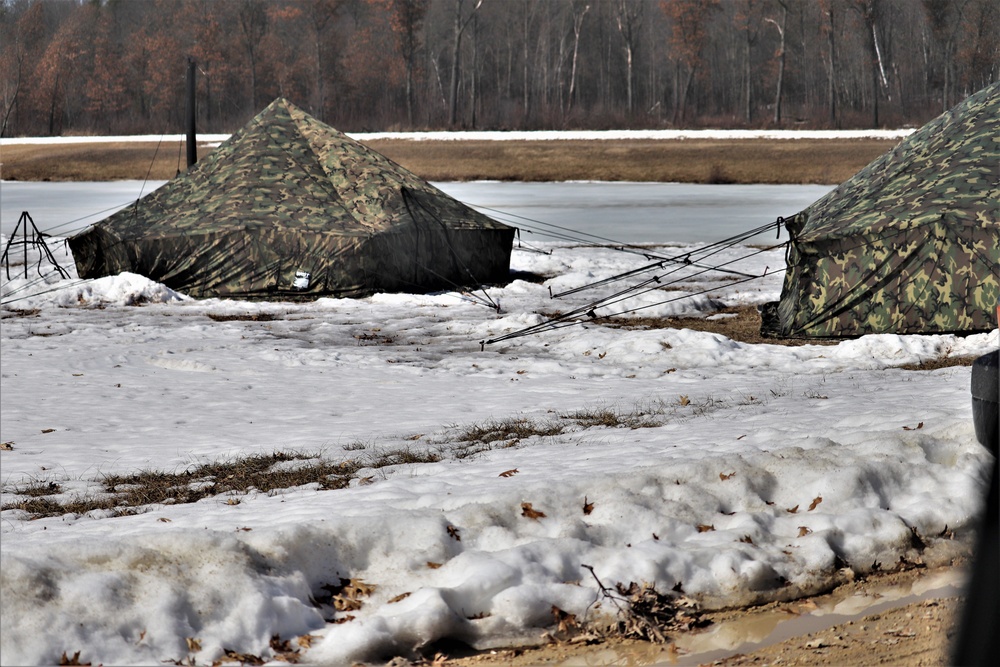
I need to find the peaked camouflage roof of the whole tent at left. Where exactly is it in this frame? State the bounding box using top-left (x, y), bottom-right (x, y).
top-left (100, 98), bottom-right (505, 238)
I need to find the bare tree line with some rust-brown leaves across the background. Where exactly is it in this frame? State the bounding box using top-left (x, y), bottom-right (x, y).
top-left (0, 0), bottom-right (1000, 136)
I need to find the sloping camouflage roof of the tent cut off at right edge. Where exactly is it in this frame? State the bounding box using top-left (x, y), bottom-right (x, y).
top-left (789, 82), bottom-right (1000, 241)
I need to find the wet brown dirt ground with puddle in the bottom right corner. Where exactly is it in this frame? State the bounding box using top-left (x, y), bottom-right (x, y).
top-left (437, 566), bottom-right (964, 667)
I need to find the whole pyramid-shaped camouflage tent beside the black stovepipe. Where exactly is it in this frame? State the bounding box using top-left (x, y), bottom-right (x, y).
top-left (69, 99), bottom-right (515, 298)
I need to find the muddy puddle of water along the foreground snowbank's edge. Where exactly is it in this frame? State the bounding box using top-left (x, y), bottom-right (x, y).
top-left (561, 568), bottom-right (966, 667)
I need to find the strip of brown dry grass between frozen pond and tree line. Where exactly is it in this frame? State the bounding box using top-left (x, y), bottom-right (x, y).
top-left (0, 139), bottom-right (896, 184)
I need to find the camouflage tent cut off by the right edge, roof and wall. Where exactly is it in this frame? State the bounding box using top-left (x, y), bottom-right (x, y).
top-left (762, 83), bottom-right (1000, 338)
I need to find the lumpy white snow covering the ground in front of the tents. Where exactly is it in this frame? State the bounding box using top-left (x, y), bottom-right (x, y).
top-left (0, 211), bottom-right (998, 665)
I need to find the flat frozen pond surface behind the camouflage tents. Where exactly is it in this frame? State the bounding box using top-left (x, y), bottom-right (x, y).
top-left (0, 181), bottom-right (832, 243)
